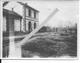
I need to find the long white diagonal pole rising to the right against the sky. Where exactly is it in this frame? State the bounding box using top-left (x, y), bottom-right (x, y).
top-left (17, 8), bottom-right (58, 46)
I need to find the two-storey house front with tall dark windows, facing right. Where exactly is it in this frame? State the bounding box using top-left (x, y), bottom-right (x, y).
top-left (22, 4), bottom-right (39, 32)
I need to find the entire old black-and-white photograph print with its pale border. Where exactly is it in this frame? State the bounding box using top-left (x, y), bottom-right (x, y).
top-left (2, 0), bottom-right (79, 59)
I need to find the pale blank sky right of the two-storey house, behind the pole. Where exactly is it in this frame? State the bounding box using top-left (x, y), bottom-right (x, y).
top-left (3, 1), bottom-right (79, 27)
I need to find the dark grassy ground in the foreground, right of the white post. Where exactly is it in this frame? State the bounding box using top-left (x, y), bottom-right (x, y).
top-left (22, 34), bottom-right (77, 57)
